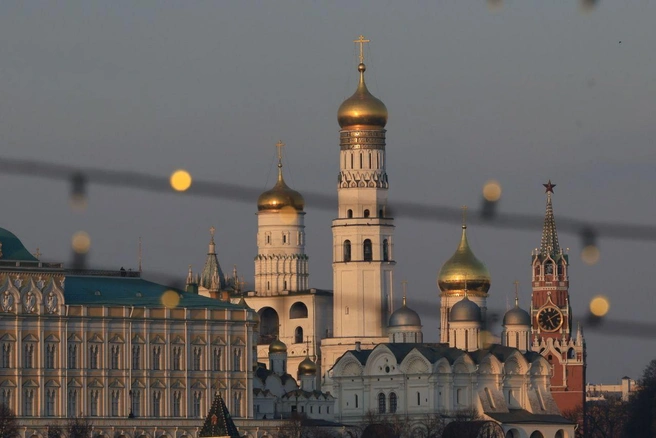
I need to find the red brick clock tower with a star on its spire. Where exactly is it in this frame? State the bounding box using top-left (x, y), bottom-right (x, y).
top-left (531, 180), bottom-right (586, 412)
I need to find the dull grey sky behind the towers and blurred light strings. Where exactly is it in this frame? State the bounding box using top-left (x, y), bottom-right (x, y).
top-left (0, 0), bottom-right (656, 383)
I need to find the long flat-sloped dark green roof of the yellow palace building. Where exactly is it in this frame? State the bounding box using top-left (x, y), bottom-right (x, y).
top-left (64, 275), bottom-right (243, 309)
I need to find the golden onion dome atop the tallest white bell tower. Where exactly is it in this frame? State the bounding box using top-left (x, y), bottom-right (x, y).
top-left (337, 63), bottom-right (387, 128)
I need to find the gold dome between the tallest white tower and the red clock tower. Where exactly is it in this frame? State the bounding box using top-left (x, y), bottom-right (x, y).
top-left (437, 225), bottom-right (490, 295)
